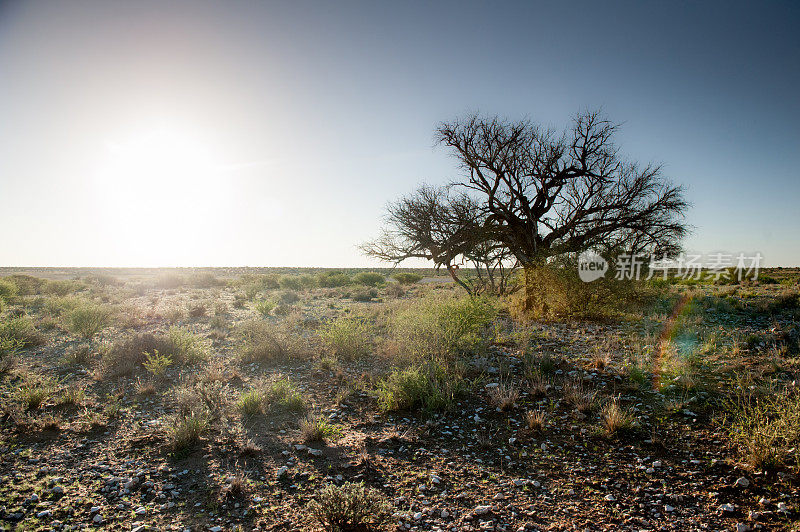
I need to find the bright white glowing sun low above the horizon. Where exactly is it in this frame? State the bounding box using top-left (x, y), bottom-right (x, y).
top-left (96, 127), bottom-right (231, 266)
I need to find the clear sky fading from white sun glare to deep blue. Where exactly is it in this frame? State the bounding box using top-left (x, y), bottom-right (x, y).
top-left (0, 1), bottom-right (800, 266)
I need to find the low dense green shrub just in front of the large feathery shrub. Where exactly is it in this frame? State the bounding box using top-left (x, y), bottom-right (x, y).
top-left (377, 363), bottom-right (465, 412)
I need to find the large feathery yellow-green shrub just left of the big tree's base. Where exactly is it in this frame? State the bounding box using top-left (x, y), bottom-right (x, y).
top-left (391, 297), bottom-right (497, 360)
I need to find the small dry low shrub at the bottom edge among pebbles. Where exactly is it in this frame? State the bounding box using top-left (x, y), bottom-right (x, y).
top-left (309, 482), bottom-right (392, 532)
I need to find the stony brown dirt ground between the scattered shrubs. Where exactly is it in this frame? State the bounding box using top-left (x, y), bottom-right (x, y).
top-left (0, 270), bottom-right (800, 532)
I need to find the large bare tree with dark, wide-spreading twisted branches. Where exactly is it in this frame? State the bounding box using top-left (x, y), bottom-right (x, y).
top-left (436, 112), bottom-right (688, 309)
